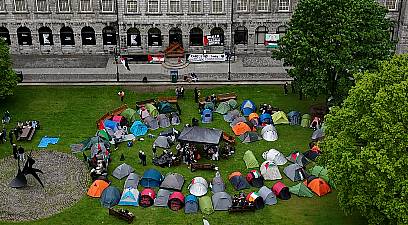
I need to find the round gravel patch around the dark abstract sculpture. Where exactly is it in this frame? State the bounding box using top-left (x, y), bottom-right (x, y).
top-left (0, 151), bottom-right (90, 221)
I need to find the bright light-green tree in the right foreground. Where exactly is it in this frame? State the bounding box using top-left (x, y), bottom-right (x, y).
top-left (320, 55), bottom-right (408, 224)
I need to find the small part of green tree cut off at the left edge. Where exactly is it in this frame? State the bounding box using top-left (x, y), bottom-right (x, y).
top-left (0, 38), bottom-right (17, 99)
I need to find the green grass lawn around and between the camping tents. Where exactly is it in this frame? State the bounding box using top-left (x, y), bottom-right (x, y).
top-left (0, 85), bottom-right (366, 225)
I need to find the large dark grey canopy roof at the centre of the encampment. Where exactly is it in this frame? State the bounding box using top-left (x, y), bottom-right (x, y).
top-left (178, 126), bottom-right (222, 145)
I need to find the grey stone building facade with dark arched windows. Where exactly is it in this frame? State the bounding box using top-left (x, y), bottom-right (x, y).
top-left (0, 0), bottom-right (408, 54)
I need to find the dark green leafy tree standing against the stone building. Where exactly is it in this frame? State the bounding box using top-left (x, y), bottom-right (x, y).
top-left (273, 0), bottom-right (395, 102)
